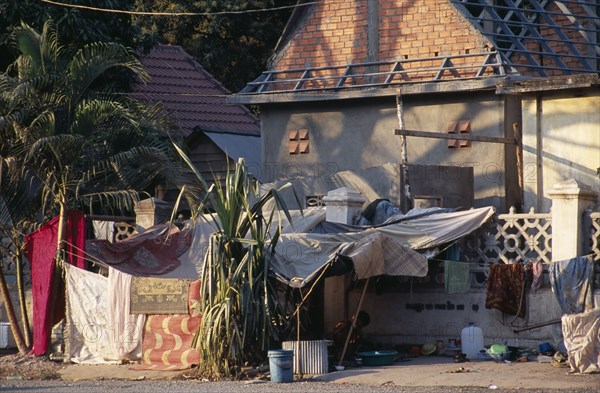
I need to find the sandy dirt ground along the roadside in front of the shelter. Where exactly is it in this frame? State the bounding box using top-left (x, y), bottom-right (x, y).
top-left (0, 353), bottom-right (600, 391)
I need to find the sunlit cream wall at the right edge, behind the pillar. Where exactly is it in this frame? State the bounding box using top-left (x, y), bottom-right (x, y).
top-left (523, 89), bottom-right (600, 212)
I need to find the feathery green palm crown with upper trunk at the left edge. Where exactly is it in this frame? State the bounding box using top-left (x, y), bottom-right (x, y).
top-left (0, 21), bottom-right (195, 354)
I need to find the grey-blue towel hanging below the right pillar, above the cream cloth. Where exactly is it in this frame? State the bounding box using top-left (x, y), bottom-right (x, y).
top-left (548, 255), bottom-right (594, 314)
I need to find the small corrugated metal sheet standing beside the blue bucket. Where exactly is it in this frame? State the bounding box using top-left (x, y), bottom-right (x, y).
top-left (281, 340), bottom-right (329, 375)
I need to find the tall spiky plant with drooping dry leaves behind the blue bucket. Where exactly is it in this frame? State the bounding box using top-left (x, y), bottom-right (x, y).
top-left (180, 146), bottom-right (300, 378)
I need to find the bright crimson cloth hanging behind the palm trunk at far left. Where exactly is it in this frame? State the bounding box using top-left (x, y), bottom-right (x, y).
top-left (25, 211), bottom-right (85, 356)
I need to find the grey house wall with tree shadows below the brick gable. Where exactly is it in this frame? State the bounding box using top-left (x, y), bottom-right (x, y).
top-left (261, 92), bottom-right (506, 211)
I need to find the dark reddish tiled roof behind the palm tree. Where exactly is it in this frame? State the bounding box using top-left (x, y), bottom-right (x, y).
top-left (133, 45), bottom-right (260, 137)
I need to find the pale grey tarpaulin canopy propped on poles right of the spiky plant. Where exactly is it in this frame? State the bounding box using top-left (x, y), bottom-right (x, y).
top-left (271, 207), bottom-right (494, 287)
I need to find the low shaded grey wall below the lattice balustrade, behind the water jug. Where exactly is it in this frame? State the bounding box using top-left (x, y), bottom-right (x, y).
top-left (349, 284), bottom-right (600, 348)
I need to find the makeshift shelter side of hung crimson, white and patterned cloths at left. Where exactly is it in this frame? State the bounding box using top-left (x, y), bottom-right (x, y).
top-left (28, 212), bottom-right (217, 369)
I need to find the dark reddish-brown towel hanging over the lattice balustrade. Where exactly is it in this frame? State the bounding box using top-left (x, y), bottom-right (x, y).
top-left (485, 263), bottom-right (525, 318)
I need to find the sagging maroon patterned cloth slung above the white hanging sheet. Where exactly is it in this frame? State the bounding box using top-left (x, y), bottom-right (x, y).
top-left (86, 224), bottom-right (193, 276)
